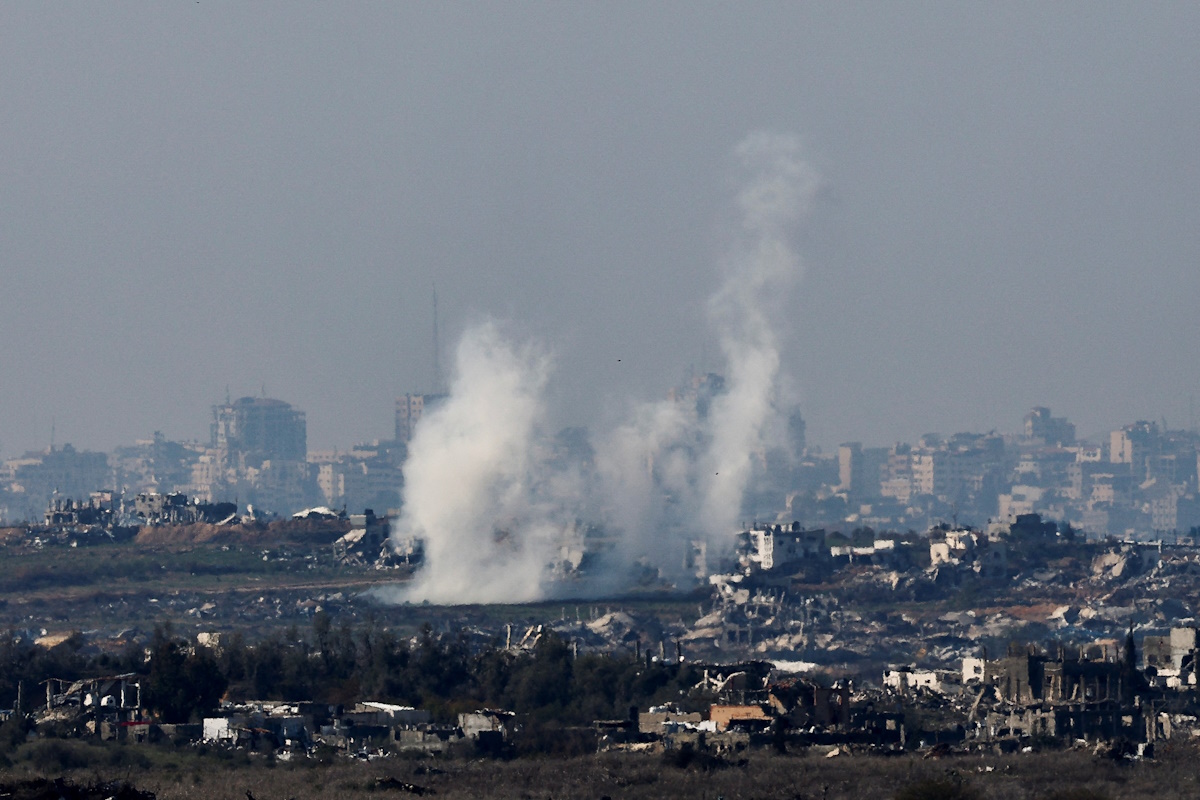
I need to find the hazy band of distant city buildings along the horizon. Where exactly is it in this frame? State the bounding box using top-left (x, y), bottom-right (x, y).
top-left (0, 391), bottom-right (1200, 542)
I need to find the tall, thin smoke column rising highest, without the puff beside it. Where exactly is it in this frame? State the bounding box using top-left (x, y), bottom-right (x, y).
top-left (698, 133), bottom-right (820, 541)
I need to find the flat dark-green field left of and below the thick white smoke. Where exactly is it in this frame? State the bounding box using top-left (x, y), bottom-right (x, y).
top-left (0, 539), bottom-right (708, 639)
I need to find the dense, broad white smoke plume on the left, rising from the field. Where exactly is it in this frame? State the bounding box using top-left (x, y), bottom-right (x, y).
top-left (396, 324), bottom-right (553, 604)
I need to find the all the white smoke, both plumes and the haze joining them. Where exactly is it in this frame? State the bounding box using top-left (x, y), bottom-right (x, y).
top-left (392, 133), bottom-right (818, 603)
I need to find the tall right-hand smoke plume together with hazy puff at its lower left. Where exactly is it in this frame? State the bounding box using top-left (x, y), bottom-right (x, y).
top-left (595, 133), bottom-right (820, 566)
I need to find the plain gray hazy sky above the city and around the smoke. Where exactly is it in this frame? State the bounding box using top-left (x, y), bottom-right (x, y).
top-left (0, 0), bottom-right (1200, 457)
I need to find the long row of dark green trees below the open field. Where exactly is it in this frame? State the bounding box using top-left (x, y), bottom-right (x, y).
top-left (0, 614), bottom-right (701, 724)
